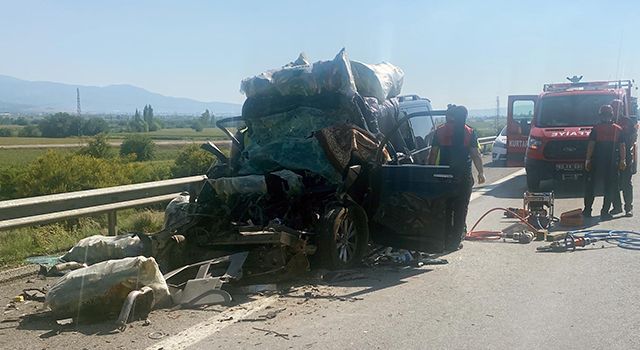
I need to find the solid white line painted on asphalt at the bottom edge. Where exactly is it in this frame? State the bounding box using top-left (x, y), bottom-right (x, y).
top-left (146, 295), bottom-right (278, 350)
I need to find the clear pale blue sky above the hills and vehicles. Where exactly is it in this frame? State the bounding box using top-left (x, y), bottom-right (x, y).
top-left (0, 0), bottom-right (640, 108)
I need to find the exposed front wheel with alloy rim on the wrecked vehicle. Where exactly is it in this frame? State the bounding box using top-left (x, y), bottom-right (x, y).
top-left (314, 204), bottom-right (369, 270)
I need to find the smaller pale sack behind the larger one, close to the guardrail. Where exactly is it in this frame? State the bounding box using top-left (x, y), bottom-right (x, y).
top-left (61, 234), bottom-right (148, 265)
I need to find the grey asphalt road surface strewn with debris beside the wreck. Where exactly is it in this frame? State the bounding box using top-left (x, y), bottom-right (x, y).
top-left (0, 157), bottom-right (640, 349)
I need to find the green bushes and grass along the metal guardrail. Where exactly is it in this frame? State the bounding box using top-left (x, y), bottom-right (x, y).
top-left (0, 130), bottom-right (220, 268)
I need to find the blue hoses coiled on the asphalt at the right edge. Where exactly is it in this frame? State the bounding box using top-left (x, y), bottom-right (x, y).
top-left (536, 230), bottom-right (640, 253)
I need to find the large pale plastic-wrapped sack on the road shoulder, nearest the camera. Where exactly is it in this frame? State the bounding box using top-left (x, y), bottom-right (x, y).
top-left (45, 256), bottom-right (169, 318)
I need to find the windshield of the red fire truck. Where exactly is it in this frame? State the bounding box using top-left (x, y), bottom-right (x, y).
top-left (538, 94), bottom-right (615, 127)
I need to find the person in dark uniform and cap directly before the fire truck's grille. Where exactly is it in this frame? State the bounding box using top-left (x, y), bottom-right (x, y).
top-left (582, 105), bottom-right (627, 221)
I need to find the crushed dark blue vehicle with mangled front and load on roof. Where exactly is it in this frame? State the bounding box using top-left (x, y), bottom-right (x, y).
top-left (151, 50), bottom-right (464, 279)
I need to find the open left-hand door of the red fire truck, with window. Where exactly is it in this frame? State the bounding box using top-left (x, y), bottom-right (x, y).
top-left (507, 95), bottom-right (538, 166)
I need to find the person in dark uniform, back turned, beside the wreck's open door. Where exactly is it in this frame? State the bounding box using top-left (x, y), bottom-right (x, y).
top-left (429, 105), bottom-right (485, 251)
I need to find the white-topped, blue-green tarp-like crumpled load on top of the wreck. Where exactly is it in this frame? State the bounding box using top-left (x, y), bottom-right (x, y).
top-left (238, 49), bottom-right (404, 183)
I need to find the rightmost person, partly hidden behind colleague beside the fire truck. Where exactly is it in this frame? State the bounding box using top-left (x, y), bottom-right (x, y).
top-left (609, 109), bottom-right (638, 217)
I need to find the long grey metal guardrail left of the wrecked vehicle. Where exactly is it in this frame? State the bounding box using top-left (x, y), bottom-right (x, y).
top-left (0, 175), bottom-right (206, 235)
